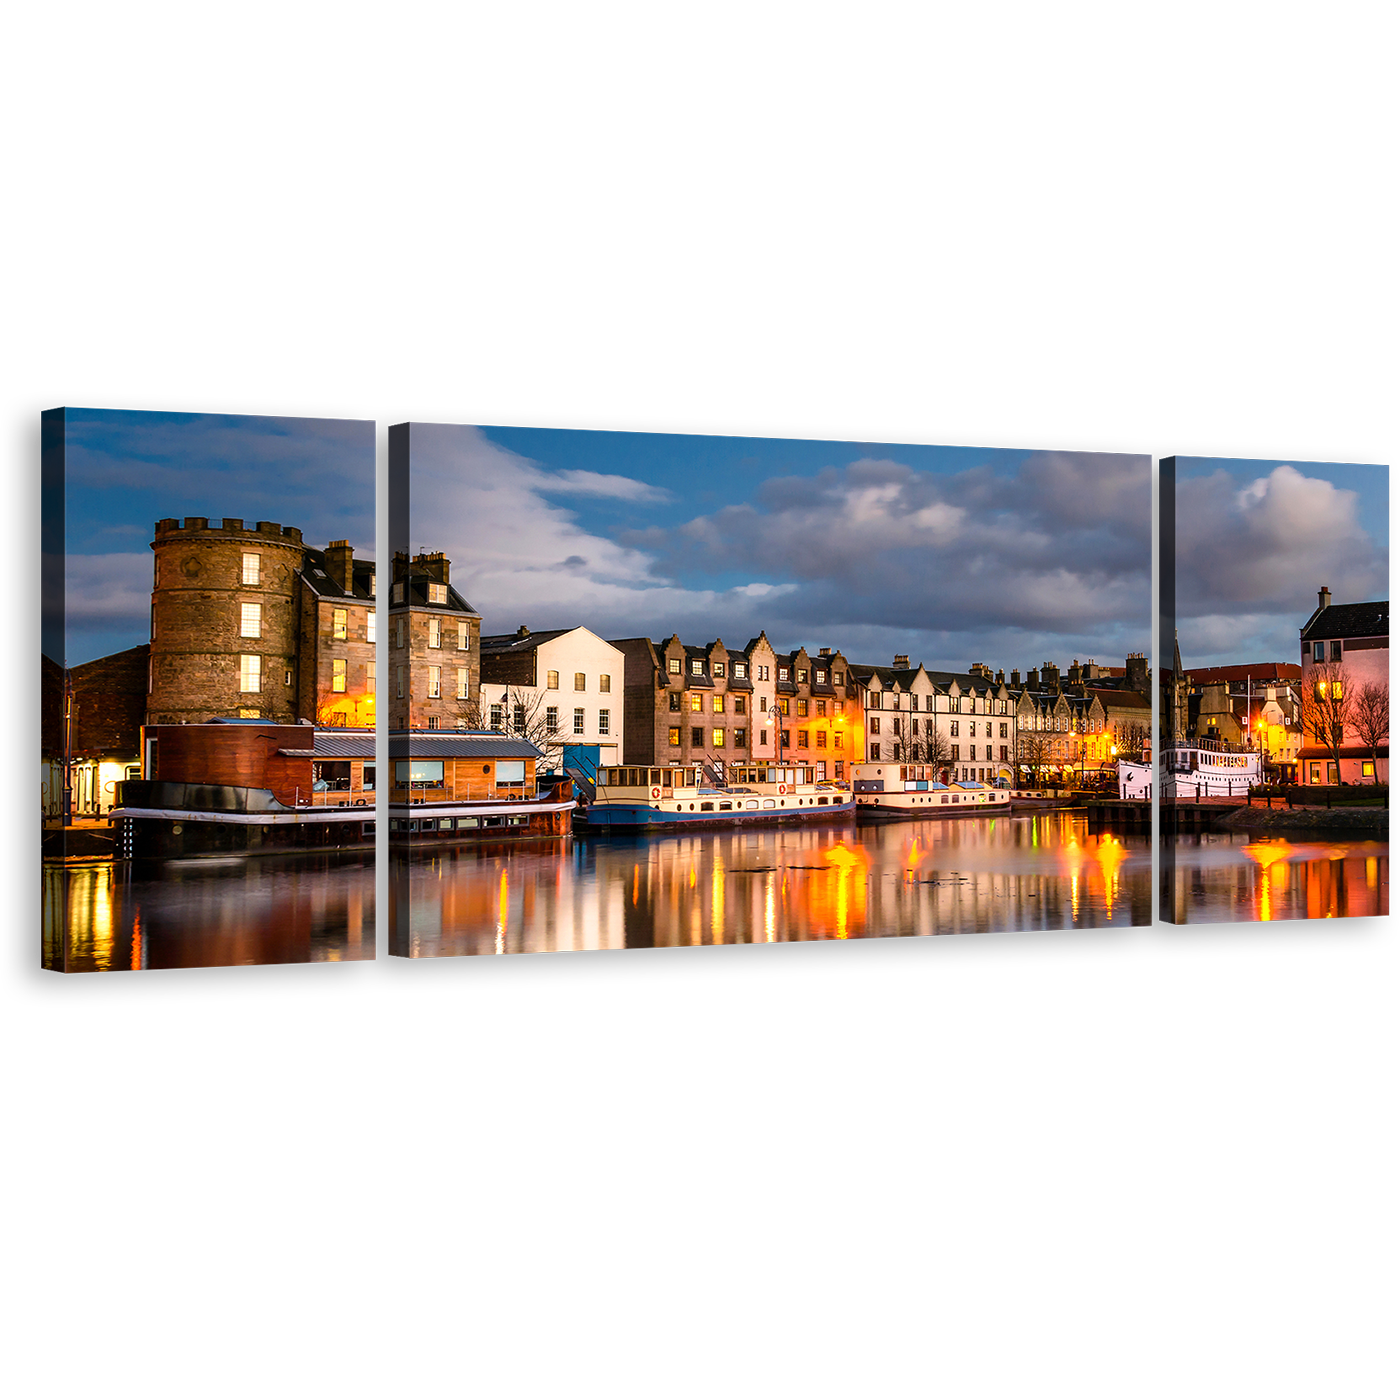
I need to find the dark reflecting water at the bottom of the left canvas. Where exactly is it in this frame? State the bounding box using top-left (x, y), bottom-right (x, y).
top-left (43, 851), bottom-right (375, 972)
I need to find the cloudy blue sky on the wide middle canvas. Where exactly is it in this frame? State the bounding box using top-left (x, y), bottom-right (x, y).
top-left (409, 424), bottom-right (1151, 672)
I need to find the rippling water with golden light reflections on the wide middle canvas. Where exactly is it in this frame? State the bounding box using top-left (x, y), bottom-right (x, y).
top-left (393, 812), bottom-right (1152, 956)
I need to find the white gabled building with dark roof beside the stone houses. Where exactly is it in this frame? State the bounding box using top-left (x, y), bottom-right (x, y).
top-left (480, 627), bottom-right (626, 769)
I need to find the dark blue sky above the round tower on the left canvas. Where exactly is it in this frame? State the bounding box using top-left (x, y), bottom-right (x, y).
top-left (61, 409), bottom-right (375, 666)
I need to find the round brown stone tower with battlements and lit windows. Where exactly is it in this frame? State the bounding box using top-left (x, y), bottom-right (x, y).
top-left (146, 515), bottom-right (305, 724)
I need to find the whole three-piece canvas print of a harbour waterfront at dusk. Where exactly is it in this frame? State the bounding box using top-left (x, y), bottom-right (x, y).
top-left (42, 407), bottom-right (1389, 972)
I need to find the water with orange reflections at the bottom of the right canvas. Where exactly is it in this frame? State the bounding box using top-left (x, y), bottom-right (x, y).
top-left (1172, 832), bottom-right (1390, 924)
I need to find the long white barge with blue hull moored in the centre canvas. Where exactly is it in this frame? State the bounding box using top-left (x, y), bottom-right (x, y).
top-left (574, 763), bottom-right (855, 833)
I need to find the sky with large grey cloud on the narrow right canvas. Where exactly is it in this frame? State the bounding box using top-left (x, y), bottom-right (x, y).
top-left (1176, 458), bottom-right (1390, 668)
